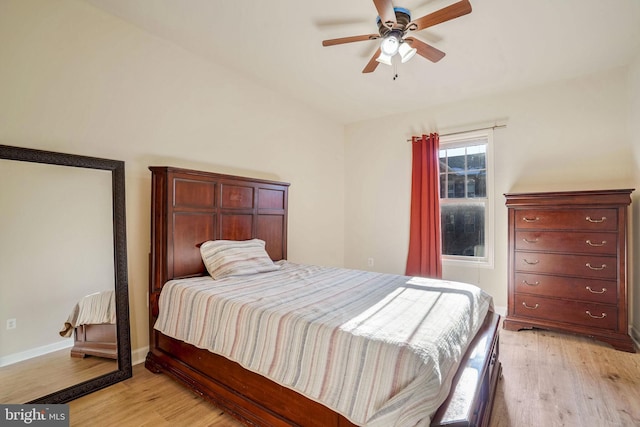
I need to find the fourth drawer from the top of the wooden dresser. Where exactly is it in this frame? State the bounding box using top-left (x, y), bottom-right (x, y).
top-left (515, 273), bottom-right (618, 304)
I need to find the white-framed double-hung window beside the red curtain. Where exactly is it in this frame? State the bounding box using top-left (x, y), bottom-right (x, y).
top-left (440, 129), bottom-right (493, 266)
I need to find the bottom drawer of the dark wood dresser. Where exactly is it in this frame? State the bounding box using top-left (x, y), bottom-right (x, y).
top-left (514, 294), bottom-right (618, 329)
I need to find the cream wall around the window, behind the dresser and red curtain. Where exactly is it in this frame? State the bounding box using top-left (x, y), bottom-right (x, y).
top-left (345, 69), bottom-right (637, 314)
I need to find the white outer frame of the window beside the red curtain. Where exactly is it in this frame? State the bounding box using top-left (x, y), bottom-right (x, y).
top-left (440, 128), bottom-right (495, 268)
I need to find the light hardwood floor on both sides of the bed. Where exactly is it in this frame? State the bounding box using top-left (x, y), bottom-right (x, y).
top-left (70, 330), bottom-right (640, 427)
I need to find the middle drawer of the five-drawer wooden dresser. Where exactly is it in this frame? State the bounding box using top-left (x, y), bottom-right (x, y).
top-left (514, 251), bottom-right (618, 280)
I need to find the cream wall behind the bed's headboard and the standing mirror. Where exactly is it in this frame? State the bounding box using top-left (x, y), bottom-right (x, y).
top-left (0, 0), bottom-right (344, 358)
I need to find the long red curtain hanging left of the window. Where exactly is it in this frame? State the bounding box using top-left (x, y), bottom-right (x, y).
top-left (405, 133), bottom-right (442, 278)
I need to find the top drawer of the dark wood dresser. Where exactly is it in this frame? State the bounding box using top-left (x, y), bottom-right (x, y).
top-left (514, 209), bottom-right (618, 231)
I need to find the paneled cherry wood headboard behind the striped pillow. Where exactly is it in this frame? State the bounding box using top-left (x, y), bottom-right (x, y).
top-left (149, 166), bottom-right (289, 316)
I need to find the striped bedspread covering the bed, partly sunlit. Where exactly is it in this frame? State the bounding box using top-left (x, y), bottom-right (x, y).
top-left (155, 261), bottom-right (492, 427)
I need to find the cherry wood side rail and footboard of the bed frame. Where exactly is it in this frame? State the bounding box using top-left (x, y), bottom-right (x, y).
top-left (145, 313), bottom-right (501, 427)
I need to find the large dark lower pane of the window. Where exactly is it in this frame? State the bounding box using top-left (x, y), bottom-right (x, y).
top-left (440, 203), bottom-right (485, 257)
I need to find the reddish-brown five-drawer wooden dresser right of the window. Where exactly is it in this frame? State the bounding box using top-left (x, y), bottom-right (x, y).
top-left (504, 189), bottom-right (635, 352)
